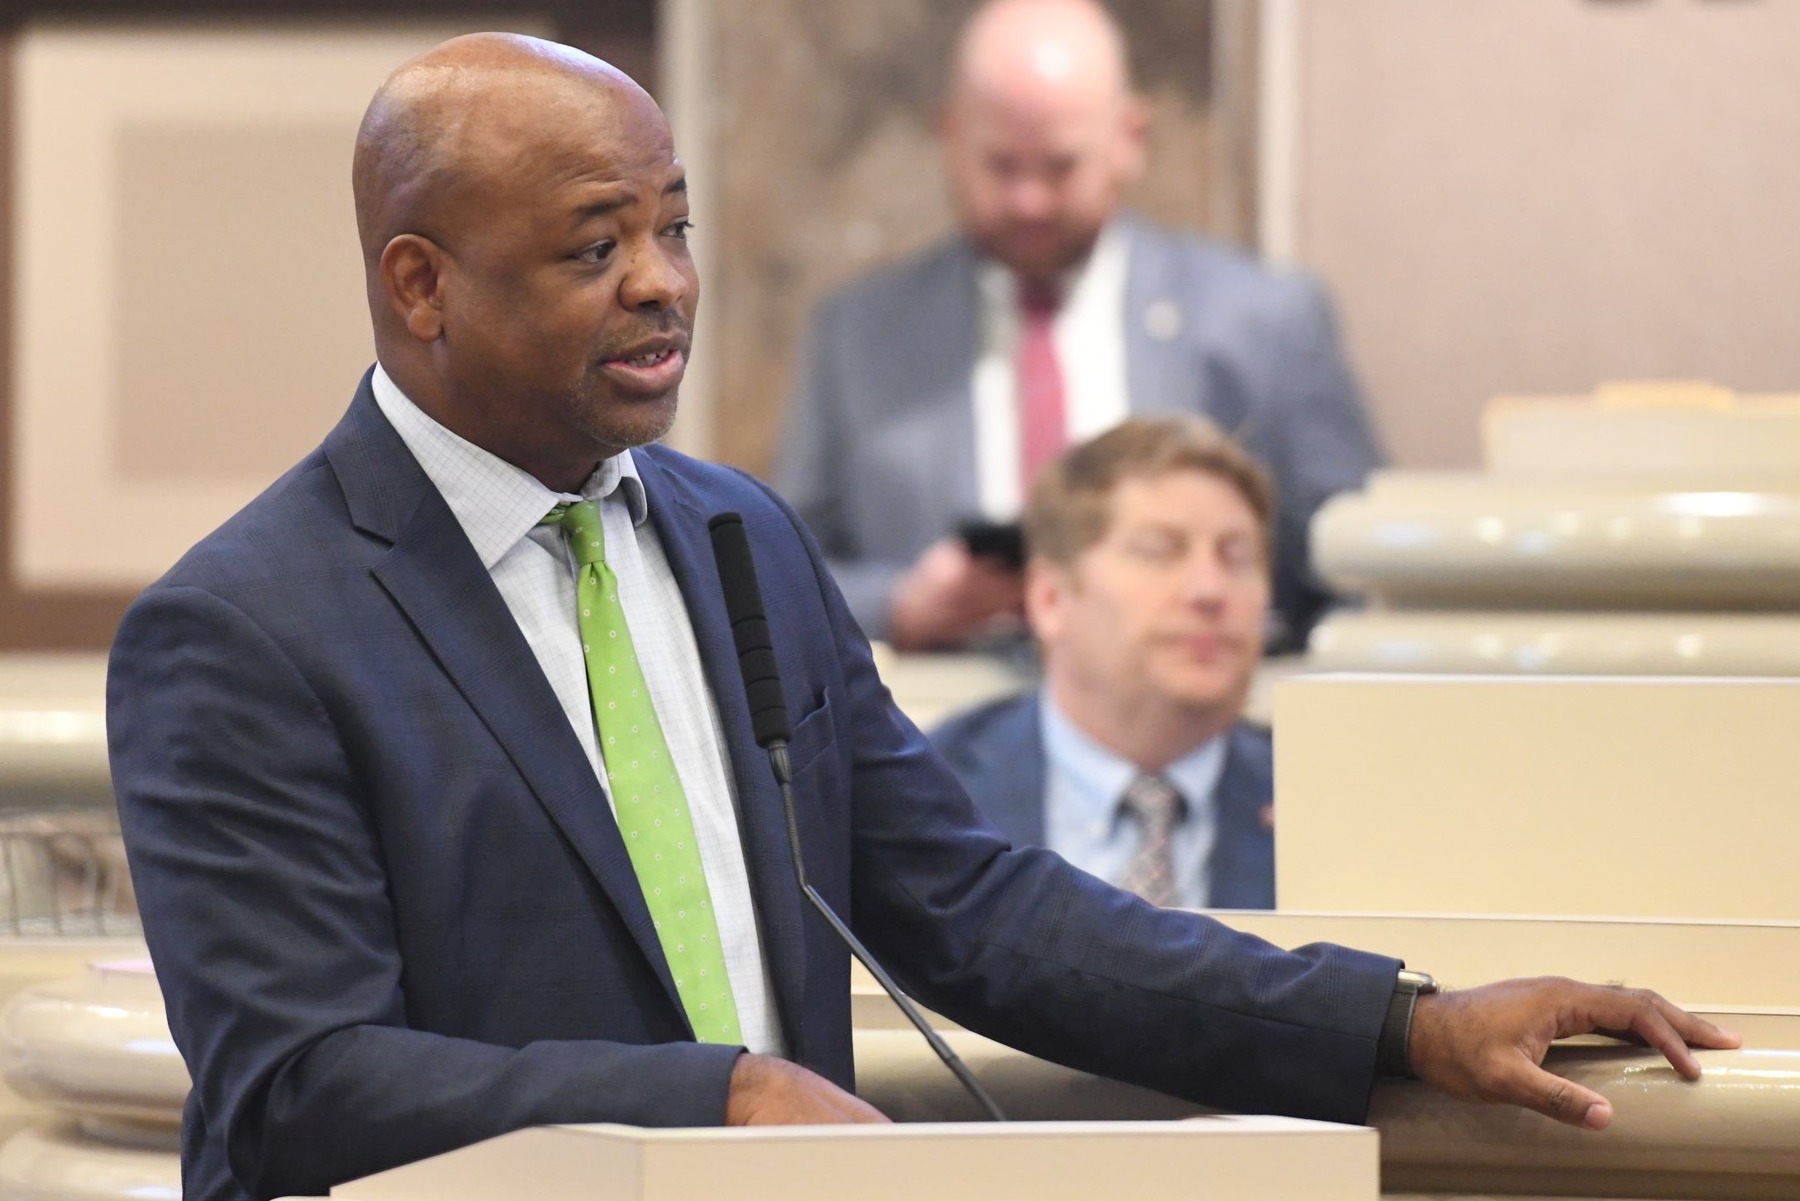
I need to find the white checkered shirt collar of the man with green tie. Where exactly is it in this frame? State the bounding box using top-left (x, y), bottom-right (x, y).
top-left (369, 364), bottom-right (650, 571)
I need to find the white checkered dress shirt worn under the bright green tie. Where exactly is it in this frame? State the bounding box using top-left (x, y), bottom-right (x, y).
top-left (373, 366), bottom-right (781, 1055)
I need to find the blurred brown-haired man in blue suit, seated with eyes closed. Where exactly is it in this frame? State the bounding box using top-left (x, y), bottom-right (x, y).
top-left (932, 416), bottom-right (1274, 909)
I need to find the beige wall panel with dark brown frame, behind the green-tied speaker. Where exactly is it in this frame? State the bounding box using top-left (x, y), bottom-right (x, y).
top-left (0, 9), bottom-right (657, 652)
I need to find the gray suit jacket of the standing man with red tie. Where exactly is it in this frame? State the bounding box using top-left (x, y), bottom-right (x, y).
top-left (776, 214), bottom-right (1381, 645)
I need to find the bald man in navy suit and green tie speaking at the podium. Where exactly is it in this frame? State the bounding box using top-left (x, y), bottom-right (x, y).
top-left (106, 34), bottom-right (1730, 1201)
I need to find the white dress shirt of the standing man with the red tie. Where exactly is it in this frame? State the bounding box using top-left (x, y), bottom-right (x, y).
top-left (970, 221), bottom-right (1130, 522)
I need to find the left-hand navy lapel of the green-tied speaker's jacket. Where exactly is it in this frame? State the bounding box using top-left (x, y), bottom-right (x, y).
top-left (326, 390), bottom-right (686, 1021)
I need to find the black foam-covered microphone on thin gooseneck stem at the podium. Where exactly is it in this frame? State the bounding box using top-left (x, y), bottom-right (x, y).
top-left (706, 513), bottom-right (1006, 1122)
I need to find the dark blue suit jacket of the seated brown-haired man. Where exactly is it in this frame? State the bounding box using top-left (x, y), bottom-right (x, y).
top-left (931, 691), bottom-right (1274, 909)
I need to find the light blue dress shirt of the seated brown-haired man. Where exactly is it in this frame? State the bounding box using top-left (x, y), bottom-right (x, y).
top-left (1039, 688), bottom-right (1226, 909)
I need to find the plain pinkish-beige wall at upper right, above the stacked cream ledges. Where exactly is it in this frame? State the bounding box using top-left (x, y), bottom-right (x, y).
top-left (1291, 0), bottom-right (1800, 466)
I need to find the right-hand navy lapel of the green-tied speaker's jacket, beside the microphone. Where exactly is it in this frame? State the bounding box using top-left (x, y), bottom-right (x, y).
top-left (634, 452), bottom-right (806, 1061)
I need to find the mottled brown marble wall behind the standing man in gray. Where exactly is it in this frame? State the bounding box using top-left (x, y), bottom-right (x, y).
top-left (695, 0), bottom-right (1253, 470)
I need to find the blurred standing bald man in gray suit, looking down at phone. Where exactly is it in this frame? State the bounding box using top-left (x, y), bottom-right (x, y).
top-left (776, 0), bottom-right (1379, 648)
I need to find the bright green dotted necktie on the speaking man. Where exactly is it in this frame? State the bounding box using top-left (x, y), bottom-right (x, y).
top-left (544, 501), bottom-right (743, 1043)
